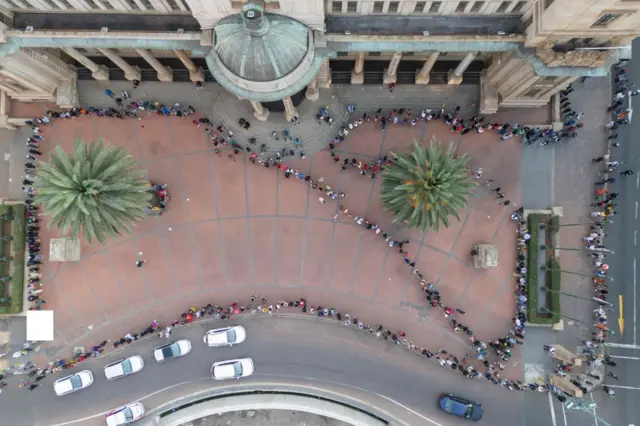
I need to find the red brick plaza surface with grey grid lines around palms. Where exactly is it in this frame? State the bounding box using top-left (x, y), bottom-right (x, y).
top-left (25, 104), bottom-right (520, 366)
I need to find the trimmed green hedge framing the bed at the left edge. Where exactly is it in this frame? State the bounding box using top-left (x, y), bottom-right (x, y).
top-left (0, 204), bottom-right (26, 314)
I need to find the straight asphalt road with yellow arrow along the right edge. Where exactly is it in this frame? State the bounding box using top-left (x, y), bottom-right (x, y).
top-left (598, 39), bottom-right (640, 426)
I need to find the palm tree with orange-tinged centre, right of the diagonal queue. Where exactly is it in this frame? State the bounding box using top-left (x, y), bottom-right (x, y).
top-left (380, 138), bottom-right (474, 231)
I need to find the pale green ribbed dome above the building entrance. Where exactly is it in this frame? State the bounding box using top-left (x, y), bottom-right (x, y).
top-left (214, 4), bottom-right (313, 82)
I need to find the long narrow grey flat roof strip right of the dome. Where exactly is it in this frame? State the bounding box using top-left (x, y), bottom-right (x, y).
top-left (327, 15), bottom-right (524, 35)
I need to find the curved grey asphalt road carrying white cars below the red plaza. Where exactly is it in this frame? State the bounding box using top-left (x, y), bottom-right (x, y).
top-left (0, 317), bottom-right (528, 426)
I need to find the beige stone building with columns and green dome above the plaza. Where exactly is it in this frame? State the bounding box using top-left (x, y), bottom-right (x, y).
top-left (0, 0), bottom-right (640, 127)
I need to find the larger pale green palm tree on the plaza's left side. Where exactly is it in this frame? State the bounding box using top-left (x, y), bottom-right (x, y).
top-left (34, 141), bottom-right (151, 244)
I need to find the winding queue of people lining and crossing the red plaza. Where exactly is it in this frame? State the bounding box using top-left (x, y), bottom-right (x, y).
top-left (6, 80), bottom-right (580, 391)
